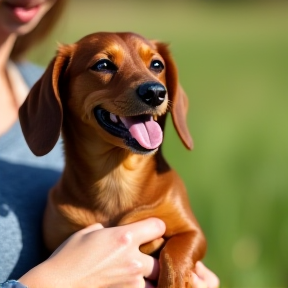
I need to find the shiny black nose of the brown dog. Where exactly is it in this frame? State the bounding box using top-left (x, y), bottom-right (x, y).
top-left (137, 82), bottom-right (166, 107)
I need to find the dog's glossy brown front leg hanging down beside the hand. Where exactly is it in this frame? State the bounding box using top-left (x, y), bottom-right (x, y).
top-left (157, 231), bottom-right (206, 288)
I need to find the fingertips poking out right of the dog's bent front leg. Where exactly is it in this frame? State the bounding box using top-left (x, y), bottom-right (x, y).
top-left (193, 261), bottom-right (220, 288)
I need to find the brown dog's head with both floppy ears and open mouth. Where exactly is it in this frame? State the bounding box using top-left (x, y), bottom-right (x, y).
top-left (19, 33), bottom-right (192, 156)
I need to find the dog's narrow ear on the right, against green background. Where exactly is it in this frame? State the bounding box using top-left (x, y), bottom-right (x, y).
top-left (154, 42), bottom-right (193, 150)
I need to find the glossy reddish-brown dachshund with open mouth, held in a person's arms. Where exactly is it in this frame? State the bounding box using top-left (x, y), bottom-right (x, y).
top-left (20, 33), bottom-right (206, 288)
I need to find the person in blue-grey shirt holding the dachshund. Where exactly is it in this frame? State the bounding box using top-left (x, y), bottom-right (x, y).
top-left (0, 0), bottom-right (219, 288)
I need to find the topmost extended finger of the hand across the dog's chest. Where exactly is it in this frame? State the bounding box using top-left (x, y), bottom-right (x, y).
top-left (122, 218), bottom-right (166, 246)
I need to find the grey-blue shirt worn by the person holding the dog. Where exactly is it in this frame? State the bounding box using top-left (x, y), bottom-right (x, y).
top-left (0, 62), bottom-right (64, 283)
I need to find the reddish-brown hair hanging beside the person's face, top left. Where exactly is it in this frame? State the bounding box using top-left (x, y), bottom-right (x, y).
top-left (10, 0), bottom-right (67, 60)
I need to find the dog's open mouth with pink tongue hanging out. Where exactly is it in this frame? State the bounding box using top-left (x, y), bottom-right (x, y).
top-left (94, 106), bottom-right (163, 154)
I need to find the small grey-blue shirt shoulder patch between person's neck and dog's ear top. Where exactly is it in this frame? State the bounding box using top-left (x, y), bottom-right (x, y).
top-left (15, 61), bottom-right (44, 87)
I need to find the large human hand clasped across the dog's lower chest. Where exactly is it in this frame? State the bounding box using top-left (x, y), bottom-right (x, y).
top-left (19, 218), bottom-right (165, 288)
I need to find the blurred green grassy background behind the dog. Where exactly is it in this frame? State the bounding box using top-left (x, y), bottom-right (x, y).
top-left (29, 0), bottom-right (288, 288)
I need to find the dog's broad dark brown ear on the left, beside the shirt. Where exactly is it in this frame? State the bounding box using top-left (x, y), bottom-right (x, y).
top-left (19, 46), bottom-right (70, 156)
